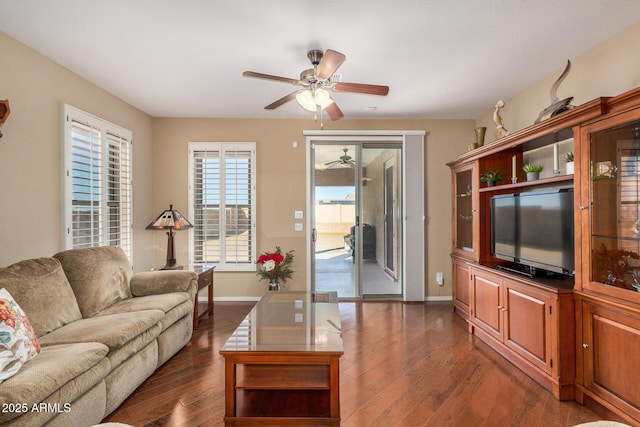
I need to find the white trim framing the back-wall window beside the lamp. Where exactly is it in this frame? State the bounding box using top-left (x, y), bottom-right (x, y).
top-left (187, 142), bottom-right (258, 272)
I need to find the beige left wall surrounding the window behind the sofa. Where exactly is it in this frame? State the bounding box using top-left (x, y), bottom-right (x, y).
top-left (0, 32), bottom-right (155, 270)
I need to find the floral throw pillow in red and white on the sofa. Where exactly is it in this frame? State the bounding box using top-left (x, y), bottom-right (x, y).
top-left (0, 288), bottom-right (40, 383)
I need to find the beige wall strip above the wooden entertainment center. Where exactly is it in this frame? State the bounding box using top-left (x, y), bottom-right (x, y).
top-left (478, 21), bottom-right (640, 139)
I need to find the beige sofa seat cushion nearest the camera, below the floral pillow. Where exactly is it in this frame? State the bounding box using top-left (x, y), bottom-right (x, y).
top-left (0, 342), bottom-right (110, 424)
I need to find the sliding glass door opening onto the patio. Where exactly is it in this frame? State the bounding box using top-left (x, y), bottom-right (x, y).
top-left (311, 143), bottom-right (402, 298)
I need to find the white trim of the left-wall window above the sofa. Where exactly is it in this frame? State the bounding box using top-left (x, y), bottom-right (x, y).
top-left (60, 104), bottom-right (133, 265)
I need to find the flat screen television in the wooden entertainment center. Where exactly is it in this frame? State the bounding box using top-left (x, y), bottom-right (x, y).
top-left (490, 188), bottom-right (575, 276)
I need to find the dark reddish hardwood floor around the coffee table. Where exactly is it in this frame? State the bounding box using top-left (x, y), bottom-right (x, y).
top-left (105, 302), bottom-right (600, 427)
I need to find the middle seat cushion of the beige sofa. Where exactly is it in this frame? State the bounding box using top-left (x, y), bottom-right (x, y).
top-left (40, 310), bottom-right (164, 369)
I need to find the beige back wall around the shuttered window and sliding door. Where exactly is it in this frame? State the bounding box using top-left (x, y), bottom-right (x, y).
top-left (153, 114), bottom-right (474, 298)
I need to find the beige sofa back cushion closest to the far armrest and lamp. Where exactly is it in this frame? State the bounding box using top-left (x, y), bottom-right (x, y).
top-left (54, 246), bottom-right (132, 318)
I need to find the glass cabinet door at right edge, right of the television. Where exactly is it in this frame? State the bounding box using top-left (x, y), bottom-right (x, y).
top-left (583, 120), bottom-right (640, 292)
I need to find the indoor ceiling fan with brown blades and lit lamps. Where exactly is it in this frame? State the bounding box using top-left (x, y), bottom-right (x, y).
top-left (242, 49), bottom-right (389, 121)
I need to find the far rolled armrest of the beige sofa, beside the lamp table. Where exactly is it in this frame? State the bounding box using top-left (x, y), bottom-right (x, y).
top-left (131, 270), bottom-right (198, 298)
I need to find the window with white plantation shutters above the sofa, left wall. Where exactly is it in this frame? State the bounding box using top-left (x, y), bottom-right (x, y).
top-left (62, 105), bottom-right (133, 260)
